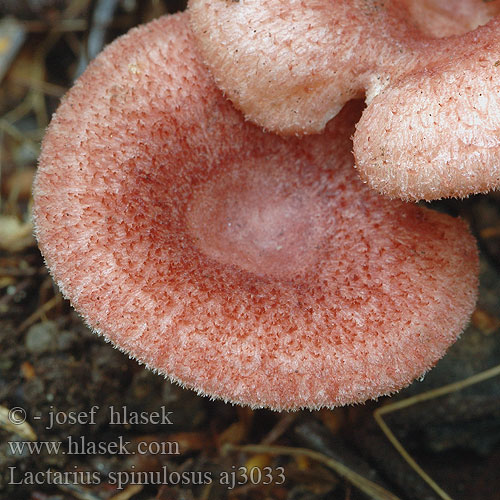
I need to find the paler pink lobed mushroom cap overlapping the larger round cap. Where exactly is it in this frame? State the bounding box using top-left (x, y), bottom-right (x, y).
top-left (189, 0), bottom-right (500, 200)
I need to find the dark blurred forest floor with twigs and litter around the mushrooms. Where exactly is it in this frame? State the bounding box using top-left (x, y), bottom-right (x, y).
top-left (0, 0), bottom-right (500, 500)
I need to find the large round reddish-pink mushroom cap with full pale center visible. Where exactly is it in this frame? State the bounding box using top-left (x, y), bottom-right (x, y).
top-left (34, 13), bottom-right (478, 410)
